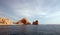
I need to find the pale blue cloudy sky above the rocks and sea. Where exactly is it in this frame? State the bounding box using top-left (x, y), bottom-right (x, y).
top-left (0, 0), bottom-right (60, 24)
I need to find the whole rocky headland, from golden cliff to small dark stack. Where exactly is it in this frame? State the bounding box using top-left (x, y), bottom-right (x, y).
top-left (0, 17), bottom-right (38, 25)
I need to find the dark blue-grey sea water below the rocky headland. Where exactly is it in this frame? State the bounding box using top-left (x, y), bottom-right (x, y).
top-left (0, 25), bottom-right (60, 35)
